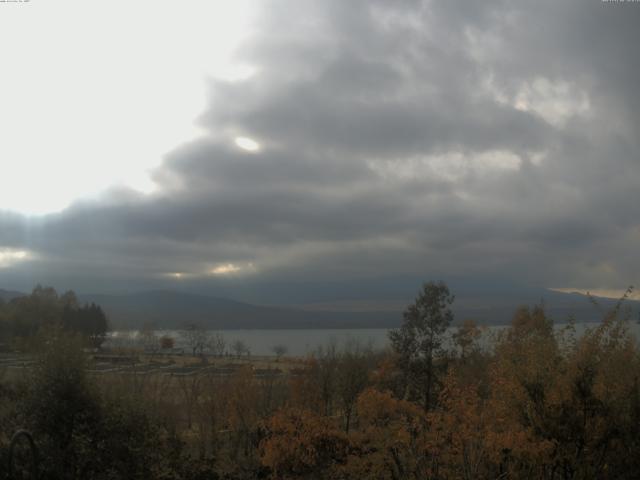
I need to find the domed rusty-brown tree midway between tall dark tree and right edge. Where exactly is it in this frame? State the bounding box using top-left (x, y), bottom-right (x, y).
top-left (485, 306), bottom-right (568, 478)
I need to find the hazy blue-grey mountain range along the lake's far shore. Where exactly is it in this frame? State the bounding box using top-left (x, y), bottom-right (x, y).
top-left (80, 289), bottom-right (640, 329)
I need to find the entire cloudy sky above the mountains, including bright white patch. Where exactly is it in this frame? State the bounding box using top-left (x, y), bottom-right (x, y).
top-left (0, 0), bottom-right (640, 303)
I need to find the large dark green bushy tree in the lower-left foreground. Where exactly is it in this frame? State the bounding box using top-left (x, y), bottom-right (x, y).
top-left (20, 327), bottom-right (180, 480)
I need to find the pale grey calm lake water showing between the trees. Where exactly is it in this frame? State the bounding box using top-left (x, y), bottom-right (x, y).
top-left (106, 322), bottom-right (640, 356)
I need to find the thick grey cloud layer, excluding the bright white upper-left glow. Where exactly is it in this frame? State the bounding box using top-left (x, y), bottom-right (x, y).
top-left (0, 0), bottom-right (640, 298)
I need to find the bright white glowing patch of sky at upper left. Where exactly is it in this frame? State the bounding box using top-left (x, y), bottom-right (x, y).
top-left (0, 0), bottom-right (255, 214)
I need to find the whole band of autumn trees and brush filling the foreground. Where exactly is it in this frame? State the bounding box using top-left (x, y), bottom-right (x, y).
top-left (0, 282), bottom-right (640, 480)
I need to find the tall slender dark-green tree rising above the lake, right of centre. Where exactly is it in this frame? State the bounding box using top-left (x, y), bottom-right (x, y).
top-left (389, 282), bottom-right (454, 411)
